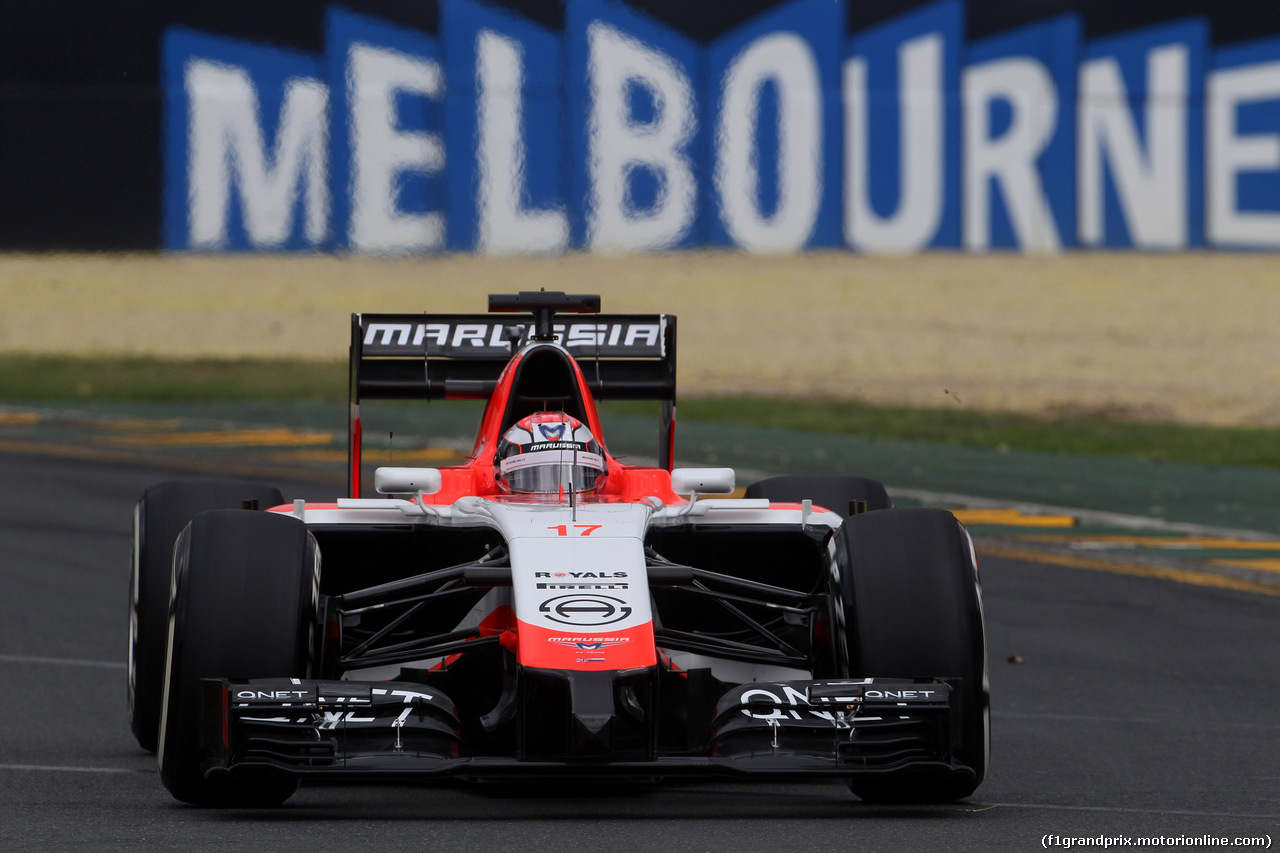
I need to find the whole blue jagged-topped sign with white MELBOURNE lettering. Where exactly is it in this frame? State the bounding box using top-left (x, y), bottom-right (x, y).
top-left (163, 0), bottom-right (1280, 254)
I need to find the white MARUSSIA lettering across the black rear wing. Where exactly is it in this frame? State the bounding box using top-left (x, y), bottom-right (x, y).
top-left (361, 315), bottom-right (666, 359)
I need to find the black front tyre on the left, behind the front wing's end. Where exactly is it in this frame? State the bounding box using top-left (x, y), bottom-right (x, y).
top-left (159, 510), bottom-right (320, 807)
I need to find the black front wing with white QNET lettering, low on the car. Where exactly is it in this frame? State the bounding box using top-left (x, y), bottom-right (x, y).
top-left (201, 679), bottom-right (973, 779)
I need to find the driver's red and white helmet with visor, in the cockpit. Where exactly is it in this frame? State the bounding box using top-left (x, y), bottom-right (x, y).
top-left (494, 411), bottom-right (607, 494)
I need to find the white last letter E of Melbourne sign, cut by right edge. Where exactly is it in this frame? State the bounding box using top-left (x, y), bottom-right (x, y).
top-left (1204, 61), bottom-right (1280, 248)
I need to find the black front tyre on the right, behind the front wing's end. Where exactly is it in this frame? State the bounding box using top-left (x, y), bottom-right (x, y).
top-left (833, 508), bottom-right (991, 803)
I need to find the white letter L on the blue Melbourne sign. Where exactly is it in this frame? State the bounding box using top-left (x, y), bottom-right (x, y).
top-left (476, 29), bottom-right (568, 255)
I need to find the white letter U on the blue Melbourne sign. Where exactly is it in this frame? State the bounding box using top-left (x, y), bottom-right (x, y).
top-left (844, 33), bottom-right (946, 252)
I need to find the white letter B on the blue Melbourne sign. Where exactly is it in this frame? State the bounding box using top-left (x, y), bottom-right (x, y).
top-left (586, 20), bottom-right (698, 251)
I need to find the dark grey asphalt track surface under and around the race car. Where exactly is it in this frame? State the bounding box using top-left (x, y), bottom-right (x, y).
top-left (0, 453), bottom-right (1280, 852)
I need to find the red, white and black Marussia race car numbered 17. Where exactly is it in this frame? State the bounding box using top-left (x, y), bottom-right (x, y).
top-left (129, 292), bottom-right (989, 806)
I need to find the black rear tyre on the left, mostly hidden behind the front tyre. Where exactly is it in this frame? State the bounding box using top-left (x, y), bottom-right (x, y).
top-left (129, 480), bottom-right (284, 752)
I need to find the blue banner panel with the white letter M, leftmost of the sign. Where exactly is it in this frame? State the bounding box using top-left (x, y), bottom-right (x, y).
top-left (163, 29), bottom-right (330, 251)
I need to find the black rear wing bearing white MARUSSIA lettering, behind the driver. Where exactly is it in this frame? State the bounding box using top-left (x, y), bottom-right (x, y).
top-left (347, 308), bottom-right (676, 497)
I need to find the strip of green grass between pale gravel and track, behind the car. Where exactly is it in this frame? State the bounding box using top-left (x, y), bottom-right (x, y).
top-left (0, 356), bottom-right (1280, 467)
